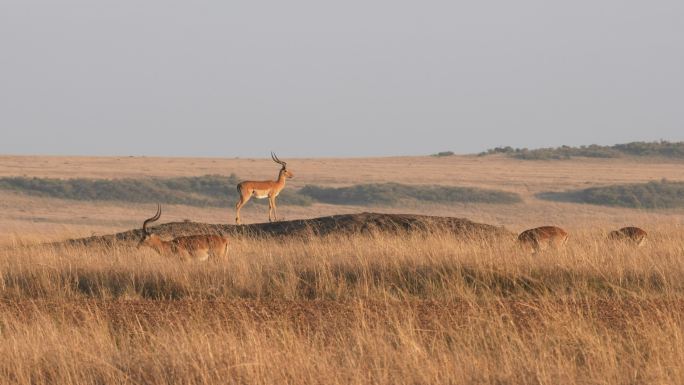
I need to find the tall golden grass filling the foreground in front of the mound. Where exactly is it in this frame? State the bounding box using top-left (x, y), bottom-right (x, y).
top-left (0, 227), bottom-right (684, 384)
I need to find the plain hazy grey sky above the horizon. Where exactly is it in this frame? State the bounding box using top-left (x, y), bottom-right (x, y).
top-left (0, 0), bottom-right (684, 158)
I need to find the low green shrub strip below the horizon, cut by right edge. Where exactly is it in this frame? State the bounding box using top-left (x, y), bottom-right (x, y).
top-left (537, 180), bottom-right (684, 209)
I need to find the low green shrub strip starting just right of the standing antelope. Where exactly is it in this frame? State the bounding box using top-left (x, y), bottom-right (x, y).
top-left (300, 183), bottom-right (521, 205)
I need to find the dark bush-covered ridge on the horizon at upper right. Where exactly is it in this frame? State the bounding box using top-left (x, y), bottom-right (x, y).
top-left (479, 141), bottom-right (684, 160)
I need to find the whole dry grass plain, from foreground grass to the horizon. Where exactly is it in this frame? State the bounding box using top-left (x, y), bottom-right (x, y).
top-left (0, 156), bottom-right (684, 384)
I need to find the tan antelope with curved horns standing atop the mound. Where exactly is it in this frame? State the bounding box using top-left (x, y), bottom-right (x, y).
top-left (235, 152), bottom-right (294, 224)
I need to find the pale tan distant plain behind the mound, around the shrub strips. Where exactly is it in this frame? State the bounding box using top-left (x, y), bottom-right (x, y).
top-left (0, 155), bottom-right (684, 244)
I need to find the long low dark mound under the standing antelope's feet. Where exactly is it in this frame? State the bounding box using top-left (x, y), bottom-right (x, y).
top-left (66, 213), bottom-right (512, 245)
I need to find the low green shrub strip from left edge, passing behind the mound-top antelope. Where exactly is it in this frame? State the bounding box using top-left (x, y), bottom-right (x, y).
top-left (0, 174), bottom-right (311, 207)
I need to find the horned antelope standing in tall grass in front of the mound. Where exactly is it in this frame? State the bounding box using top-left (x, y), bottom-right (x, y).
top-left (138, 205), bottom-right (228, 261)
